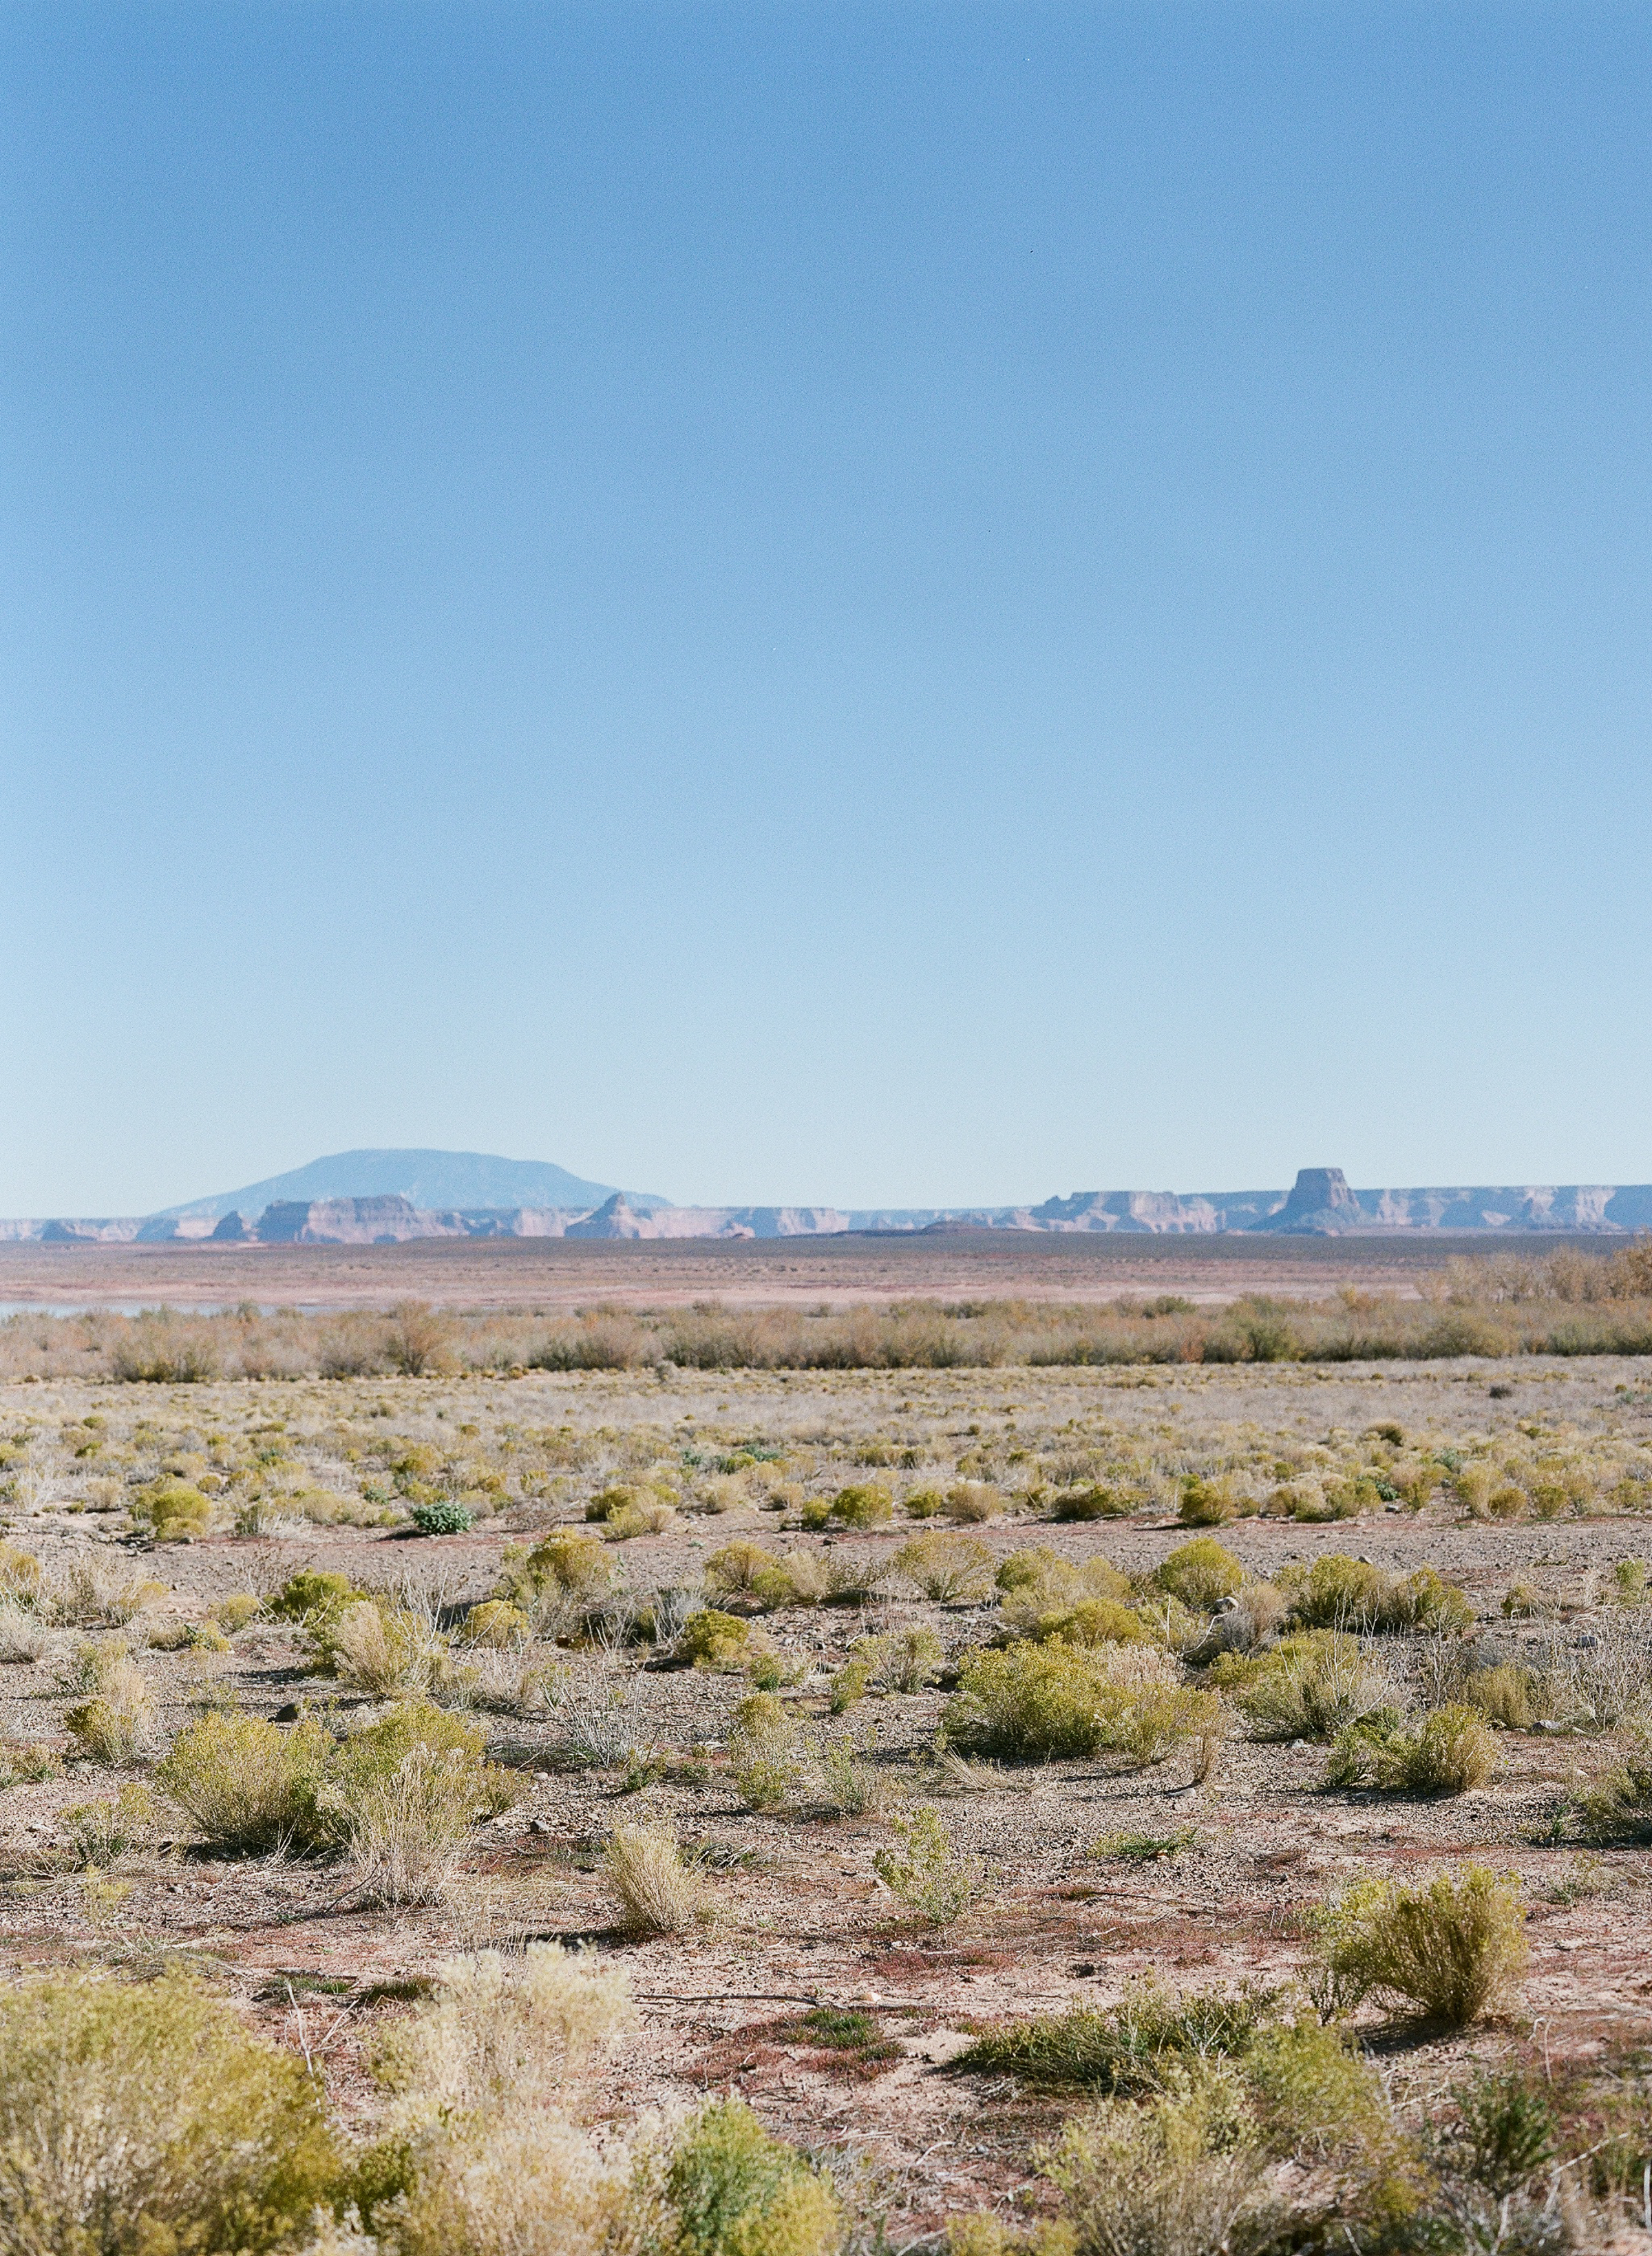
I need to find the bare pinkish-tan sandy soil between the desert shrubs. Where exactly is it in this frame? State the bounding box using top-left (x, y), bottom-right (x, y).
top-left (0, 1345), bottom-right (1652, 2238)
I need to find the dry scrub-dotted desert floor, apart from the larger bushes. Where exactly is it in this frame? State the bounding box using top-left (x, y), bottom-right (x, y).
top-left (0, 1326), bottom-right (1652, 2247)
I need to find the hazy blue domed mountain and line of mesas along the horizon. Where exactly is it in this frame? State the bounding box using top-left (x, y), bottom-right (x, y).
top-left (0, 1150), bottom-right (1652, 1245)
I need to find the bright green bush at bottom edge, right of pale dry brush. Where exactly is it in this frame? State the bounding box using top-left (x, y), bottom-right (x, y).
top-left (664, 2100), bottom-right (842, 2256)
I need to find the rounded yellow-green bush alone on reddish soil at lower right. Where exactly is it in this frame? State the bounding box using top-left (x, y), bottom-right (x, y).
top-left (1315, 1866), bottom-right (1525, 2028)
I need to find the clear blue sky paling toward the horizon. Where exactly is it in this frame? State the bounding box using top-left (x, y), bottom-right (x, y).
top-left (0, 0), bottom-right (1652, 1214)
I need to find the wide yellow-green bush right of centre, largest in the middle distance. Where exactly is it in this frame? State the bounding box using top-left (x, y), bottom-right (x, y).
top-left (941, 1640), bottom-right (1221, 1764)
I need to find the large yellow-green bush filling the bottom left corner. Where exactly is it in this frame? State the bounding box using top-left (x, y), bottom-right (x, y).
top-left (0, 1974), bottom-right (339, 2256)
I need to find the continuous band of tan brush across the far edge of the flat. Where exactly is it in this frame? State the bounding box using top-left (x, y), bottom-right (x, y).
top-left (0, 1241), bottom-right (1652, 1385)
